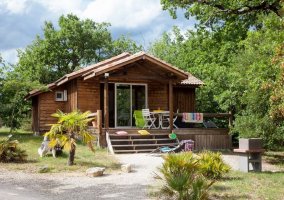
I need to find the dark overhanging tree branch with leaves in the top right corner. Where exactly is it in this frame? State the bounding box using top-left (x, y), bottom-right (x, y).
top-left (161, 0), bottom-right (284, 28)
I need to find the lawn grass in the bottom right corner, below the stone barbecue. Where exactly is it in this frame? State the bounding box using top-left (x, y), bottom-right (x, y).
top-left (149, 151), bottom-right (284, 200)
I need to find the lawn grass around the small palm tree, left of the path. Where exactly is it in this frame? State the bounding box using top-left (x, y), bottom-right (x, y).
top-left (0, 128), bottom-right (120, 173)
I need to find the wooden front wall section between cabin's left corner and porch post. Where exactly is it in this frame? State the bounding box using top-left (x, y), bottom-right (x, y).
top-left (77, 79), bottom-right (100, 112)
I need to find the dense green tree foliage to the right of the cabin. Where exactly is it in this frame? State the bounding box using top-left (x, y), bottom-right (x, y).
top-left (150, 15), bottom-right (284, 149)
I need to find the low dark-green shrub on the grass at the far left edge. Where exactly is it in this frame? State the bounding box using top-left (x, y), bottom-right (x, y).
top-left (0, 135), bottom-right (27, 162)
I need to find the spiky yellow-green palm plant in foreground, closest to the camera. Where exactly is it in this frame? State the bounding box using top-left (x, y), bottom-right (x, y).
top-left (157, 152), bottom-right (212, 200)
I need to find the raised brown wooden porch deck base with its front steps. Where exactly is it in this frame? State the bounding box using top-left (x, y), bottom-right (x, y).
top-left (102, 128), bottom-right (232, 153)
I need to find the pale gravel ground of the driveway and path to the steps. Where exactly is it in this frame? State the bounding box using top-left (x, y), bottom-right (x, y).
top-left (0, 154), bottom-right (282, 200)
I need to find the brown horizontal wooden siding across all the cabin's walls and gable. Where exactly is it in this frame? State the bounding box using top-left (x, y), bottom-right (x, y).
top-left (33, 63), bottom-right (195, 132)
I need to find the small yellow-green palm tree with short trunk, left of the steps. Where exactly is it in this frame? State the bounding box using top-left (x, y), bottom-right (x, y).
top-left (45, 110), bottom-right (94, 165)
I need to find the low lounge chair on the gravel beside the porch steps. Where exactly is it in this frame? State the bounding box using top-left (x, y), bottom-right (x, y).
top-left (150, 140), bottom-right (194, 154)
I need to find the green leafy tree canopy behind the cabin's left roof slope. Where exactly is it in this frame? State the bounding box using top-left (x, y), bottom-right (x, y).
top-left (0, 14), bottom-right (142, 130)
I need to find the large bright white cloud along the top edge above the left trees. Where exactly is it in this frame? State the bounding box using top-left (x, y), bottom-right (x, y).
top-left (32, 0), bottom-right (162, 29)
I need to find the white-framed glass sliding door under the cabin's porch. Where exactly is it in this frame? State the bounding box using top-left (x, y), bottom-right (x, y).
top-left (115, 83), bottom-right (147, 127)
